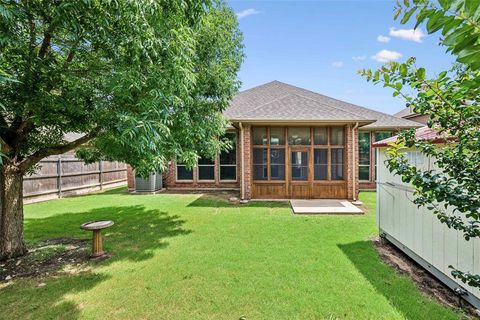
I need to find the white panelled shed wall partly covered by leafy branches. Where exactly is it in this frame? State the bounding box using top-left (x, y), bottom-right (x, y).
top-left (377, 148), bottom-right (480, 308)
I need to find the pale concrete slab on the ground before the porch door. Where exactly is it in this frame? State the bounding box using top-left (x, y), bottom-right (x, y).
top-left (290, 199), bottom-right (363, 214)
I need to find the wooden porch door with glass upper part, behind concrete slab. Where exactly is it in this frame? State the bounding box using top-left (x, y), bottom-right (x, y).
top-left (288, 148), bottom-right (312, 199)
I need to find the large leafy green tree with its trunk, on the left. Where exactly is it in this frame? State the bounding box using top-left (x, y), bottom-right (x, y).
top-left (0, 0), bottom-right (243, 260)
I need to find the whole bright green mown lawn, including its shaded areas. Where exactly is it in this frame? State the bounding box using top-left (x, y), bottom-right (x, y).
top-left (0, 190), bottom-right (461, 319)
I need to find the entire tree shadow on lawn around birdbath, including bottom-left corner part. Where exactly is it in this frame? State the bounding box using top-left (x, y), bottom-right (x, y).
top-left (0, 204), bottom-right (191, 319)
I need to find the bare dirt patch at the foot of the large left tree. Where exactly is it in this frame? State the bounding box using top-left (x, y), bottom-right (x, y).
top-left (0, 238), bottom-right (91, 282)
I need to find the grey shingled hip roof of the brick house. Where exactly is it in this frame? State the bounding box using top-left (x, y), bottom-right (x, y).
top-left (224, 81), bottom-right (420, 129)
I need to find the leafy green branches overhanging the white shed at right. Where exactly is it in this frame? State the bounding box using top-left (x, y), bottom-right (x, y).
top-left (361, 0), bottom-right (480, 287)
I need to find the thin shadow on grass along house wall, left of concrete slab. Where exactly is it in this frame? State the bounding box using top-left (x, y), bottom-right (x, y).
top-left (187, 194), bottom-right (290, 208)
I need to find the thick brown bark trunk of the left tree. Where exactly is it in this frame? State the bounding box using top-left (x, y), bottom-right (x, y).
top-left (0, 164), bottom-right (27, 260)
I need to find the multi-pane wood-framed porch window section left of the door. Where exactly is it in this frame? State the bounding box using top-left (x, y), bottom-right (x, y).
top-left (252, 127), bottom-right (285, 181)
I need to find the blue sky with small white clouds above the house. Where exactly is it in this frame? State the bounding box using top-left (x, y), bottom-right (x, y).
top-left (229, 0), bottom-right (453, 114)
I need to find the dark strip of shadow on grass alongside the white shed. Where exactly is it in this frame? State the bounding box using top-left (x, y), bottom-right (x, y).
top-left (338, 241), bottom-right (459, 319)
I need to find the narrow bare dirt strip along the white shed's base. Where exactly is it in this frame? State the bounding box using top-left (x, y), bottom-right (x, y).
top-left (372, 237), bottom-right (479, 318)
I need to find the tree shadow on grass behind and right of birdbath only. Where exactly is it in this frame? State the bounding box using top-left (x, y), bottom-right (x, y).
top-left (25, 205), bottom-right (190, 263)
